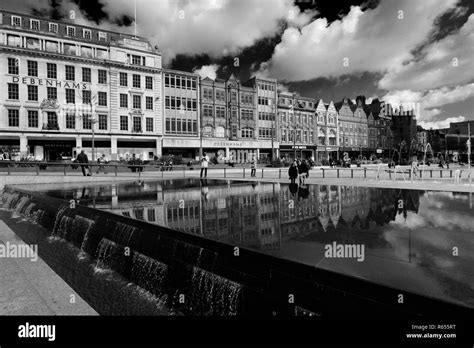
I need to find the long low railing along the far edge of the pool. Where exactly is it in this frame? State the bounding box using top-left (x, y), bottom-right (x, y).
top-left (0, 161), bottom-right (469, 183)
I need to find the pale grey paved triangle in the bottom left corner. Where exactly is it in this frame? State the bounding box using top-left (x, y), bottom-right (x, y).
top-left (0, 220), bottom-right (97, 315)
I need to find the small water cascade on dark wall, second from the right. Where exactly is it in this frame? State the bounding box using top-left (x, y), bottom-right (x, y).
top-left (132, 253), bottom-right (168, 295)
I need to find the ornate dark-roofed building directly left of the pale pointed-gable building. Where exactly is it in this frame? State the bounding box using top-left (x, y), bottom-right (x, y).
top-left (278, 92), bottom-right (317, 160)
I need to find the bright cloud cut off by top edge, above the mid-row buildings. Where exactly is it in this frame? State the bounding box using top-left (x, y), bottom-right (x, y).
top-left (100, 0), bottom-right (314, 62)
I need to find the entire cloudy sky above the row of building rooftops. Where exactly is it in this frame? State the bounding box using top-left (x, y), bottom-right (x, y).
top-left (0, 0), bottom-right (474, 128)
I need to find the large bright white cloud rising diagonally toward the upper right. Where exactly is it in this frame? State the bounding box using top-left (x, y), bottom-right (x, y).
top-left (262, 0), bottom-right (456, 81)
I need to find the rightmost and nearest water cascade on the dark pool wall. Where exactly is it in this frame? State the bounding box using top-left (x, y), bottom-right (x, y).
top-left (192, 267), bottom-right (242, 316)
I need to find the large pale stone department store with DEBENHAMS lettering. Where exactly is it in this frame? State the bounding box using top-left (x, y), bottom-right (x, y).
top-left (0, 11), bottom-right (162, 160)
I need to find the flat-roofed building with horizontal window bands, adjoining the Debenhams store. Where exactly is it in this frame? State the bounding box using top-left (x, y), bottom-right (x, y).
top-left (162, 69), bottom-right (201, 158)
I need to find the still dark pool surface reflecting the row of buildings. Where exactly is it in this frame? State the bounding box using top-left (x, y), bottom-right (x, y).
top-left (20, 179), bottom-right (474, 307)
